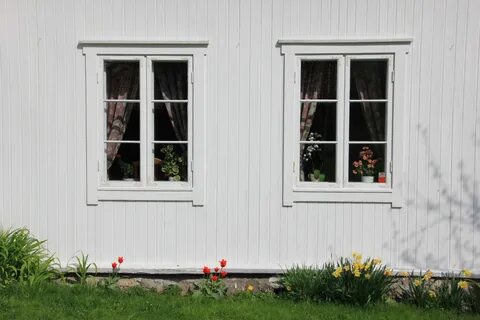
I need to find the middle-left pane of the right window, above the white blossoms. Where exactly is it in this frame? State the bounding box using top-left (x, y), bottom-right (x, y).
top-left (300, 102), bottom-right (337, 141)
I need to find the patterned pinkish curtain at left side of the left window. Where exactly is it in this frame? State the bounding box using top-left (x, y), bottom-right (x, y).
top-left (106, 63), bottom-right (139, 169)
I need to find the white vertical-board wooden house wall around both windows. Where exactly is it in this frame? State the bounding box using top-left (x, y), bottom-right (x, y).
top-left (0, 0), bottom-right (480, 273)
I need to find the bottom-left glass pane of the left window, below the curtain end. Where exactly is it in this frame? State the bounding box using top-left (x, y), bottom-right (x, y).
top-left (105, 142), bottom-right (140, 181)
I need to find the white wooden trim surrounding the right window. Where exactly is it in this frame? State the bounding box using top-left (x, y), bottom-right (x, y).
top-left (278, 38), bottom-right (412, 208)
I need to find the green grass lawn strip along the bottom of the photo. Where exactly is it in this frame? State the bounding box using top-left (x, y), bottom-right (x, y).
top-left (0, 283), bottom-right (480, 320)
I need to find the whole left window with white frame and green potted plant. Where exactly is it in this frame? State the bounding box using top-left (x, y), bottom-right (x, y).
top-left (81, 42), bottom-right (206, 205)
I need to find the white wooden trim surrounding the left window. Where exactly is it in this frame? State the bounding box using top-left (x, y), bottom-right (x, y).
top-left (78, 41), bottom-right (208, 206)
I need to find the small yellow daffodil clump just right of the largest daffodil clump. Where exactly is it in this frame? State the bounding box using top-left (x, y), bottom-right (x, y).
top-left (400, 271), bottom-right (437, 308)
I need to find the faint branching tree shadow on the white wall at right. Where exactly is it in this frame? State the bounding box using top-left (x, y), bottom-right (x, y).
top-left (396, 125), bottom-right (480, 269)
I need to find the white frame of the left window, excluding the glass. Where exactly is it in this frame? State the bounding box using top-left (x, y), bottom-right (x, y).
top-left (79, 41), bottom-right (208, 206)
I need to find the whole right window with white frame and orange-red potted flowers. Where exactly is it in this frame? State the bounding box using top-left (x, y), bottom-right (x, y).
top-left (280, 40), bottom-right (409, 206)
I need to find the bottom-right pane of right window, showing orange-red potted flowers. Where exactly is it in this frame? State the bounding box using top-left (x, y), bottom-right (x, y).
top-left (348, 144), bottom-right (385, 182)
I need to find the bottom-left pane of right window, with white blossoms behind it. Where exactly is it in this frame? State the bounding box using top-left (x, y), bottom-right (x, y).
top-left (300, 144), bottom-right (336, 182)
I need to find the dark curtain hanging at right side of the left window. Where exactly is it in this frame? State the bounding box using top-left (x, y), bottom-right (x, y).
top-left (155, 62), bottom-right (188, 142)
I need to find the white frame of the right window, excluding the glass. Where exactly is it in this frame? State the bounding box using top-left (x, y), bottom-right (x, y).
top-left (278, 39), bottom-right (412, 208)
